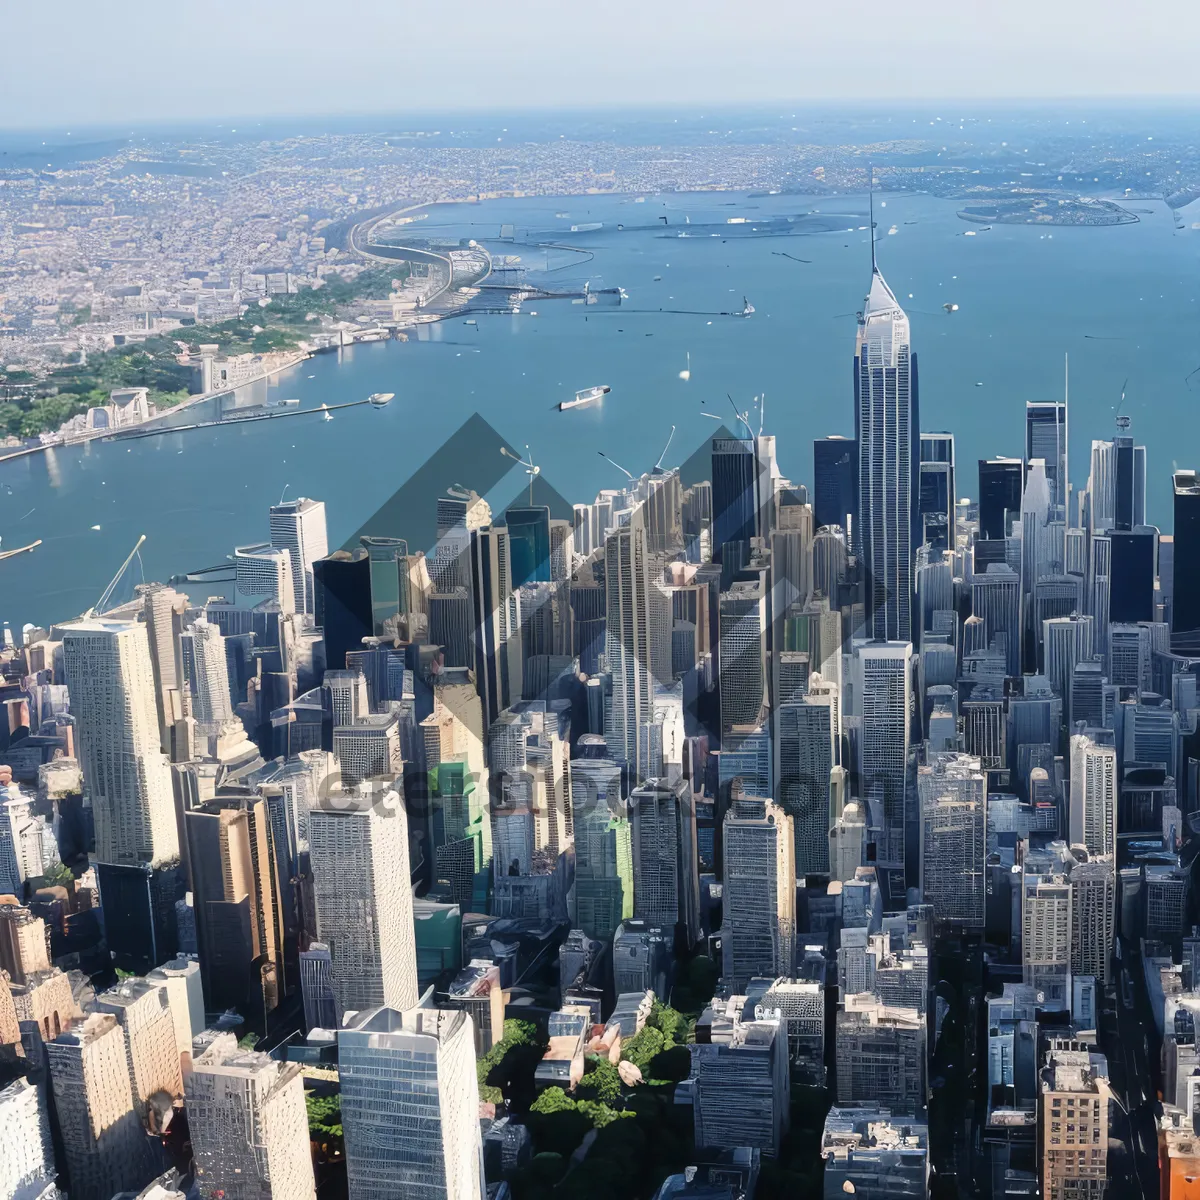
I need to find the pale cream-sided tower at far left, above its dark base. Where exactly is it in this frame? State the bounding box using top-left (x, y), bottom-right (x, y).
top-left (62, 619), bottom-right (179, 866)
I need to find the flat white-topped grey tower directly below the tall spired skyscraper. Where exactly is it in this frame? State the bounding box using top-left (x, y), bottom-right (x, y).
top-left (853, 642), bottom-right (912, 904)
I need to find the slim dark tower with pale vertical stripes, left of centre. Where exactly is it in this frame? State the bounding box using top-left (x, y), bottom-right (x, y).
top-left (470, 526), bottom-right (523, 722)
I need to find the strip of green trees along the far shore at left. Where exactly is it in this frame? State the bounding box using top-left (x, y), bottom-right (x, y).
top-left (0, 263), bottom-right (408, 438)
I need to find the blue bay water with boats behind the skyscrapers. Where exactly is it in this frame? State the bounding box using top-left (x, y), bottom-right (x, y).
top-left (0, 193), bottom-right (1200, 626)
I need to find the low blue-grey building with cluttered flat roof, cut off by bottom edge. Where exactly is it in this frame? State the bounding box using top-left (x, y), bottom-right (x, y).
top-left (821, 1104), bottom-right (929, 1200)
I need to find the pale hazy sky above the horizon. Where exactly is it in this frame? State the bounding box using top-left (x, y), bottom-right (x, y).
top-left (0, 0), bottom-right (1200, 127)
